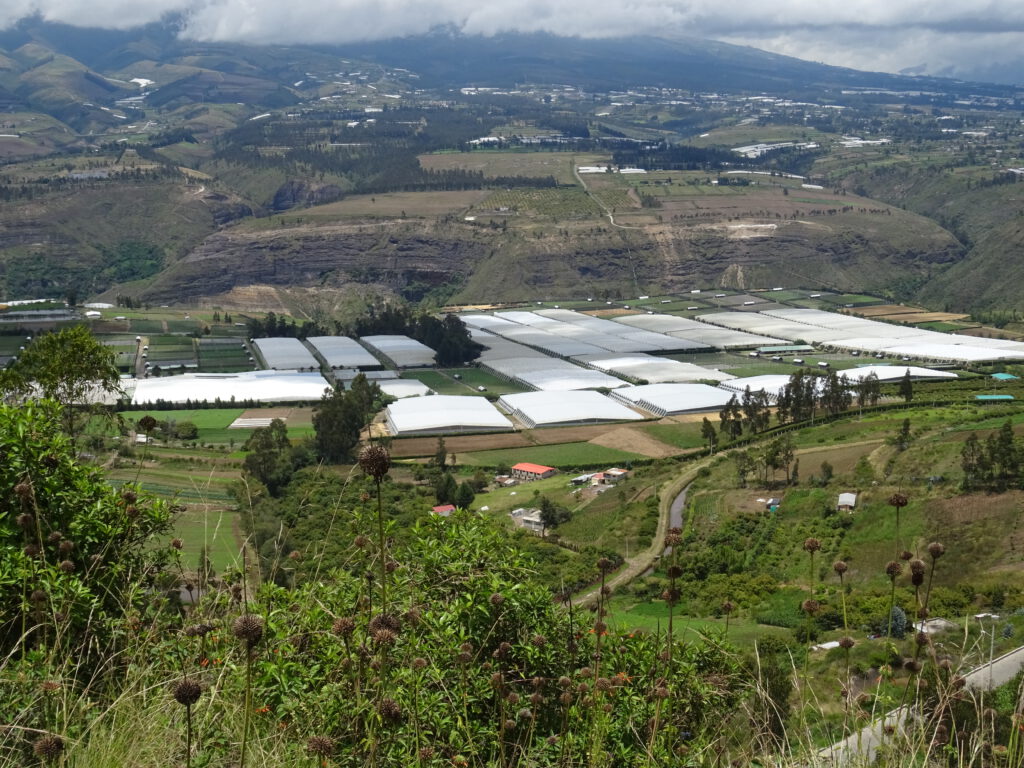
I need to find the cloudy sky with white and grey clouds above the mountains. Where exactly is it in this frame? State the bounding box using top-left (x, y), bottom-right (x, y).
top-left (0, 0), bottom-right (1024, 82)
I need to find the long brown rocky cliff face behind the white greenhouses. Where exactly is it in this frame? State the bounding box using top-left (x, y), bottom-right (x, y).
top-left (143, 211), bottom-right (961, 302)
